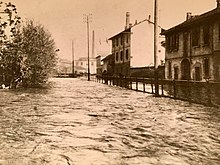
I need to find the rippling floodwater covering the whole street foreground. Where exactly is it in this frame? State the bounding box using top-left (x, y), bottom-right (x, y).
top-left (0, 79), bottom-right (220, 165)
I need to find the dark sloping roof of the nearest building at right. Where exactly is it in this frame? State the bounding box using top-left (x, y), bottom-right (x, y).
top-left (161, 7), bottom-right (220, 35)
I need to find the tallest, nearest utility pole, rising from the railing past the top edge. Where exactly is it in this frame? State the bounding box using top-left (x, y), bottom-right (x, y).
top-left (154, 0), bottom-right (159, 96)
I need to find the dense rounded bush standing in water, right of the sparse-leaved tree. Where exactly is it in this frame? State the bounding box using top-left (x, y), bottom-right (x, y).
top-left (16, 20), bottom-right (56, 87)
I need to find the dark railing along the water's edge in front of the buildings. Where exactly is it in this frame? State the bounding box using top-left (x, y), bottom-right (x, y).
top-left (96, 76), bottom-right (220, 107)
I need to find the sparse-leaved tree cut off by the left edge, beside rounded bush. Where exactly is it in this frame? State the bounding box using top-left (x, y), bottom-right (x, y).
top-left (0, 2), bottom-right (22, 87)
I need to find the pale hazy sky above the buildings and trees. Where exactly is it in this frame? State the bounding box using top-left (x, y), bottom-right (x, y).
top-left (4, 0), bottom-right (216, 60)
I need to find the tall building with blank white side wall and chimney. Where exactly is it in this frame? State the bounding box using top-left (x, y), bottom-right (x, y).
top-left (109, 12), bottom-right (164, 76)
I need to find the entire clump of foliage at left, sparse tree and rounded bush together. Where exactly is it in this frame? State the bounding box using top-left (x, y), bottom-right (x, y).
top-left (0, 2), bottom-right (56, 88)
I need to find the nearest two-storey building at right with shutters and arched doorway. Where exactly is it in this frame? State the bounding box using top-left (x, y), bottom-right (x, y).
top-left (161, 0), bottom-right (220, 81)
